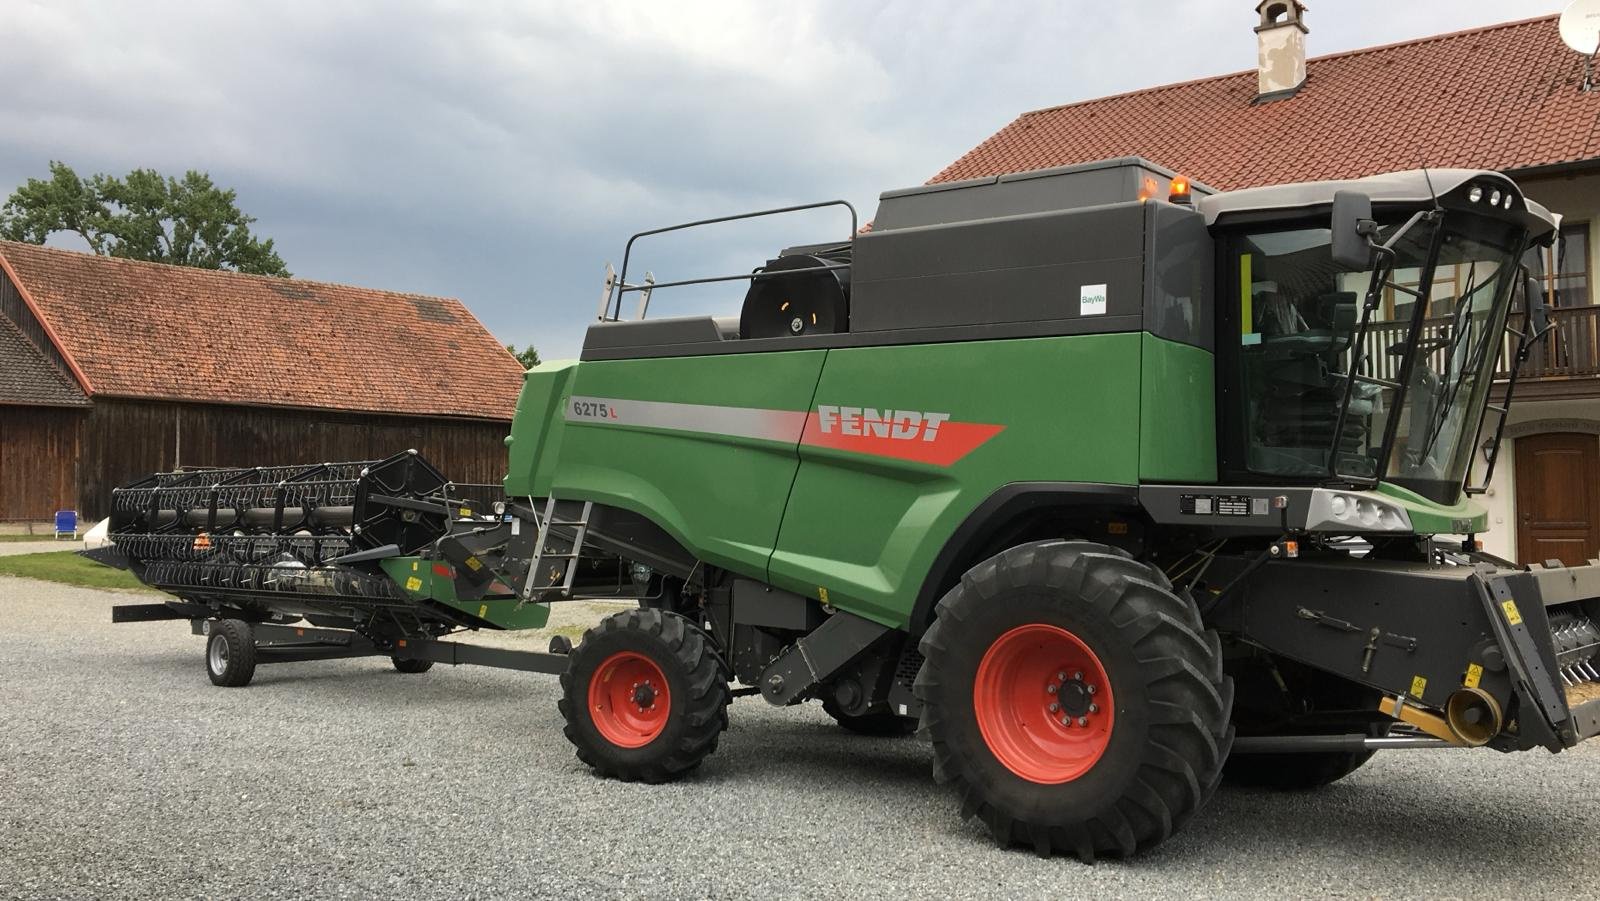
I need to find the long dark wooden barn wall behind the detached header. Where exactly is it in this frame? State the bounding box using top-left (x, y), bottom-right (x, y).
top-left (80, 398), bottom-right (510, 519)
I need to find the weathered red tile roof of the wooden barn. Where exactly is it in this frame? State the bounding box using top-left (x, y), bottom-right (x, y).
top-left (0, 242), bottom-right (523, 419)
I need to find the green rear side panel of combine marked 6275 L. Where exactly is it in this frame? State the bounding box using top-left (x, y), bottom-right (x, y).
top-left (547, 350), bottom-right (827, 578)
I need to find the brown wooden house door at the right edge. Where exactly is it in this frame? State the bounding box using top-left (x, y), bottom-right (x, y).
top-left (1517, 432), bottom-right (1600, 565)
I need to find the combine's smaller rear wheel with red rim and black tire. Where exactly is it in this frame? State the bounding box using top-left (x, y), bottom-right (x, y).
top-left (560, 610), bottom-right (730, 783)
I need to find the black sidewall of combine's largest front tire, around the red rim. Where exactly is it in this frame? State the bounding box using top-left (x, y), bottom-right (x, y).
top-left (938, 586), bottom-right (1150, 824)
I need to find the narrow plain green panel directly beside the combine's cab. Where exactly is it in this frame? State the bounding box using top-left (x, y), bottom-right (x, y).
top-left (1139, 333), bottom-right (1216, 483)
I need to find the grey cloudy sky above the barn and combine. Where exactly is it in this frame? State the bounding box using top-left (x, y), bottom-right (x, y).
top-left (0, 0), bottom-right (1563, 358)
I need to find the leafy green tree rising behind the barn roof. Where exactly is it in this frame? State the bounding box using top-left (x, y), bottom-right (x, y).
top-left (0, 160), bottom-right (290, 278)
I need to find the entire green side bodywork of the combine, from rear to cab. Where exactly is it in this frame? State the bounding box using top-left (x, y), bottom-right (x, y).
top-left (502, 333), bottom-right (1486, 626)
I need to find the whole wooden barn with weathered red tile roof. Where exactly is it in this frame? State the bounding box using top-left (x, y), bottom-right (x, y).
top-left (0, 242), bottom-right (523, 522)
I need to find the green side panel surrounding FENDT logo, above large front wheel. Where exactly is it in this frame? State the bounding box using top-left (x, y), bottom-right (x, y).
top-left (770, 333), bottom-right (1139, 626)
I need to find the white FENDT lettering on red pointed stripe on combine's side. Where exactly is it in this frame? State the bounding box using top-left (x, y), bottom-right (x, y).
top-left (800, 403), bottom-right (1005, 466)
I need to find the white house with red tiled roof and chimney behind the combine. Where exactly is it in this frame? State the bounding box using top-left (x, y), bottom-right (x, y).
top-left (931, 0), bottom-right (1600, 562)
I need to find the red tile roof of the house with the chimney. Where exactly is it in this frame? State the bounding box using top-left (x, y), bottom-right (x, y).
top-left (933, 16), bottom-right (1600, 190)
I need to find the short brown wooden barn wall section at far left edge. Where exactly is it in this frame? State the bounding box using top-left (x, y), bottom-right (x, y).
top-left (0, 406), bottom-right (86, 522)
